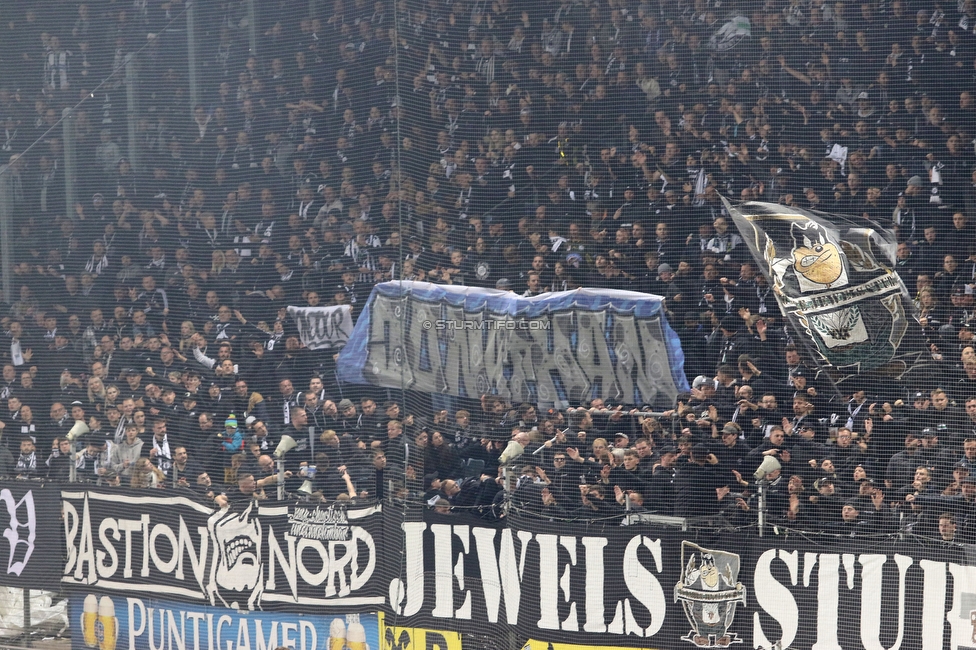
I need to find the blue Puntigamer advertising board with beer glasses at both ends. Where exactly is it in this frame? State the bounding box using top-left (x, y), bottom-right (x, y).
top-left (69, 590), bottom-right (380, 650)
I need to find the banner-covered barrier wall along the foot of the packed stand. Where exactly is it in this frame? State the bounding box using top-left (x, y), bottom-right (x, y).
top-left (0, 481), bottom-right (976, 650)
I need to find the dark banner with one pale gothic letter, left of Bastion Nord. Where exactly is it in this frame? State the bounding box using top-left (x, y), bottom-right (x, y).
top-left (0, 481), bottom-right (64, 589)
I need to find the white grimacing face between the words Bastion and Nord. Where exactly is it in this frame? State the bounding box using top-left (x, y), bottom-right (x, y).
top-left (207, 502), bottom-right (264, 609)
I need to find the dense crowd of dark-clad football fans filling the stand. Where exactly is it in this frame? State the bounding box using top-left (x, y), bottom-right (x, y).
top-left (0, 0), bottom-right (976, 541)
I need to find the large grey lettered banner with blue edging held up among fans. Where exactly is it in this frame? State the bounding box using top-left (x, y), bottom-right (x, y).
top-left (338, 282), bottom-right (688, 407)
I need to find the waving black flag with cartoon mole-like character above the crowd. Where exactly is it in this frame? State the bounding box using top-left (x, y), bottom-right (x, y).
top-left (726, 202), bottom-right (920, 380)
